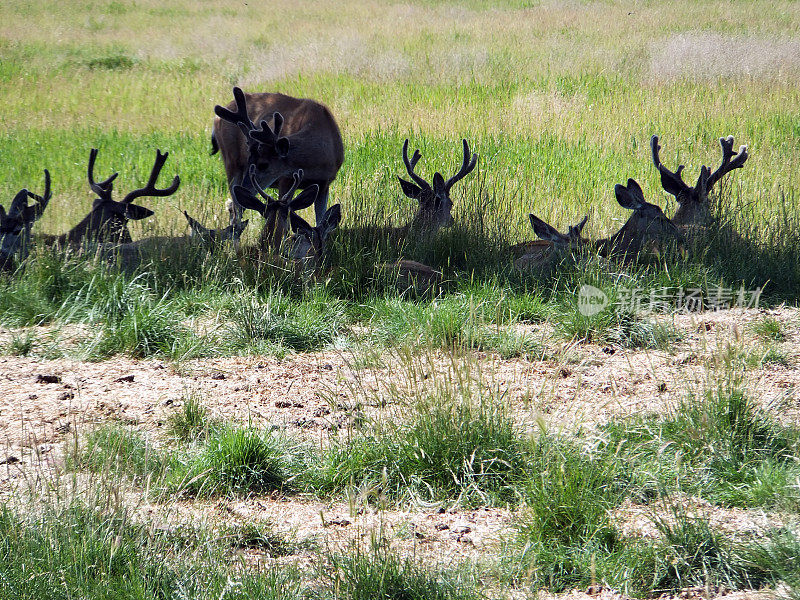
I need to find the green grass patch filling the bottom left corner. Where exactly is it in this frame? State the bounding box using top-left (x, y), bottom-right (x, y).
top-left (0, 502), bottom-right (304, 600)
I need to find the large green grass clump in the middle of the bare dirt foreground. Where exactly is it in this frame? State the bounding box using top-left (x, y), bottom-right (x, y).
top-left (311, 389), bottom-right (528, 505)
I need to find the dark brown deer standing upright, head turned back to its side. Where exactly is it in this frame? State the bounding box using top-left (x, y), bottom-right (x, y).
top-left (211, 87), bottom-right (344, 223)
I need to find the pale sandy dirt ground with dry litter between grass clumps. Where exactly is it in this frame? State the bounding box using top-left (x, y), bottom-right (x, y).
top-left (0, 308), bottom-right (800, 598)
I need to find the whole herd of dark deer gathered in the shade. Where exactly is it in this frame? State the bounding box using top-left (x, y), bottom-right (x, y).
top-left (0, 87), bottom-right (748, 279)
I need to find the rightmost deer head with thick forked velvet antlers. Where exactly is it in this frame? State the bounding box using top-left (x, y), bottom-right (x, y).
top-left (650, 135), bottom-right (747, 226)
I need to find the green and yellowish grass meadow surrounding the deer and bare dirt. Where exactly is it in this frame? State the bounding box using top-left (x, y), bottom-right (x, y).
top-left (0, 0), bottom-right (800, 600)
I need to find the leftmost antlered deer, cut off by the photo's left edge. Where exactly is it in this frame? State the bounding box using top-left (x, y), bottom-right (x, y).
top-left (0, 169), bottom-right (52, 271)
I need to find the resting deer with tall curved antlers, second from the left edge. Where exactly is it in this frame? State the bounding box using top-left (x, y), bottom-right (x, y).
top-left (37, 148), bottom-right (181, 246)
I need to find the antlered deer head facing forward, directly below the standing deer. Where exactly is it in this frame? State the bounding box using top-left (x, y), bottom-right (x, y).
top-left (233, 165), bottom-right (319, 251)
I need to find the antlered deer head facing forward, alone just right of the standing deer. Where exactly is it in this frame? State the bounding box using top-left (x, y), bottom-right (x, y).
top-left (398, 139), bottom-right (478, 231)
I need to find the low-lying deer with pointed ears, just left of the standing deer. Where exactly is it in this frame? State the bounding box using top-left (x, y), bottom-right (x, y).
top-left (98, 200), bottom-right (248, 273)
